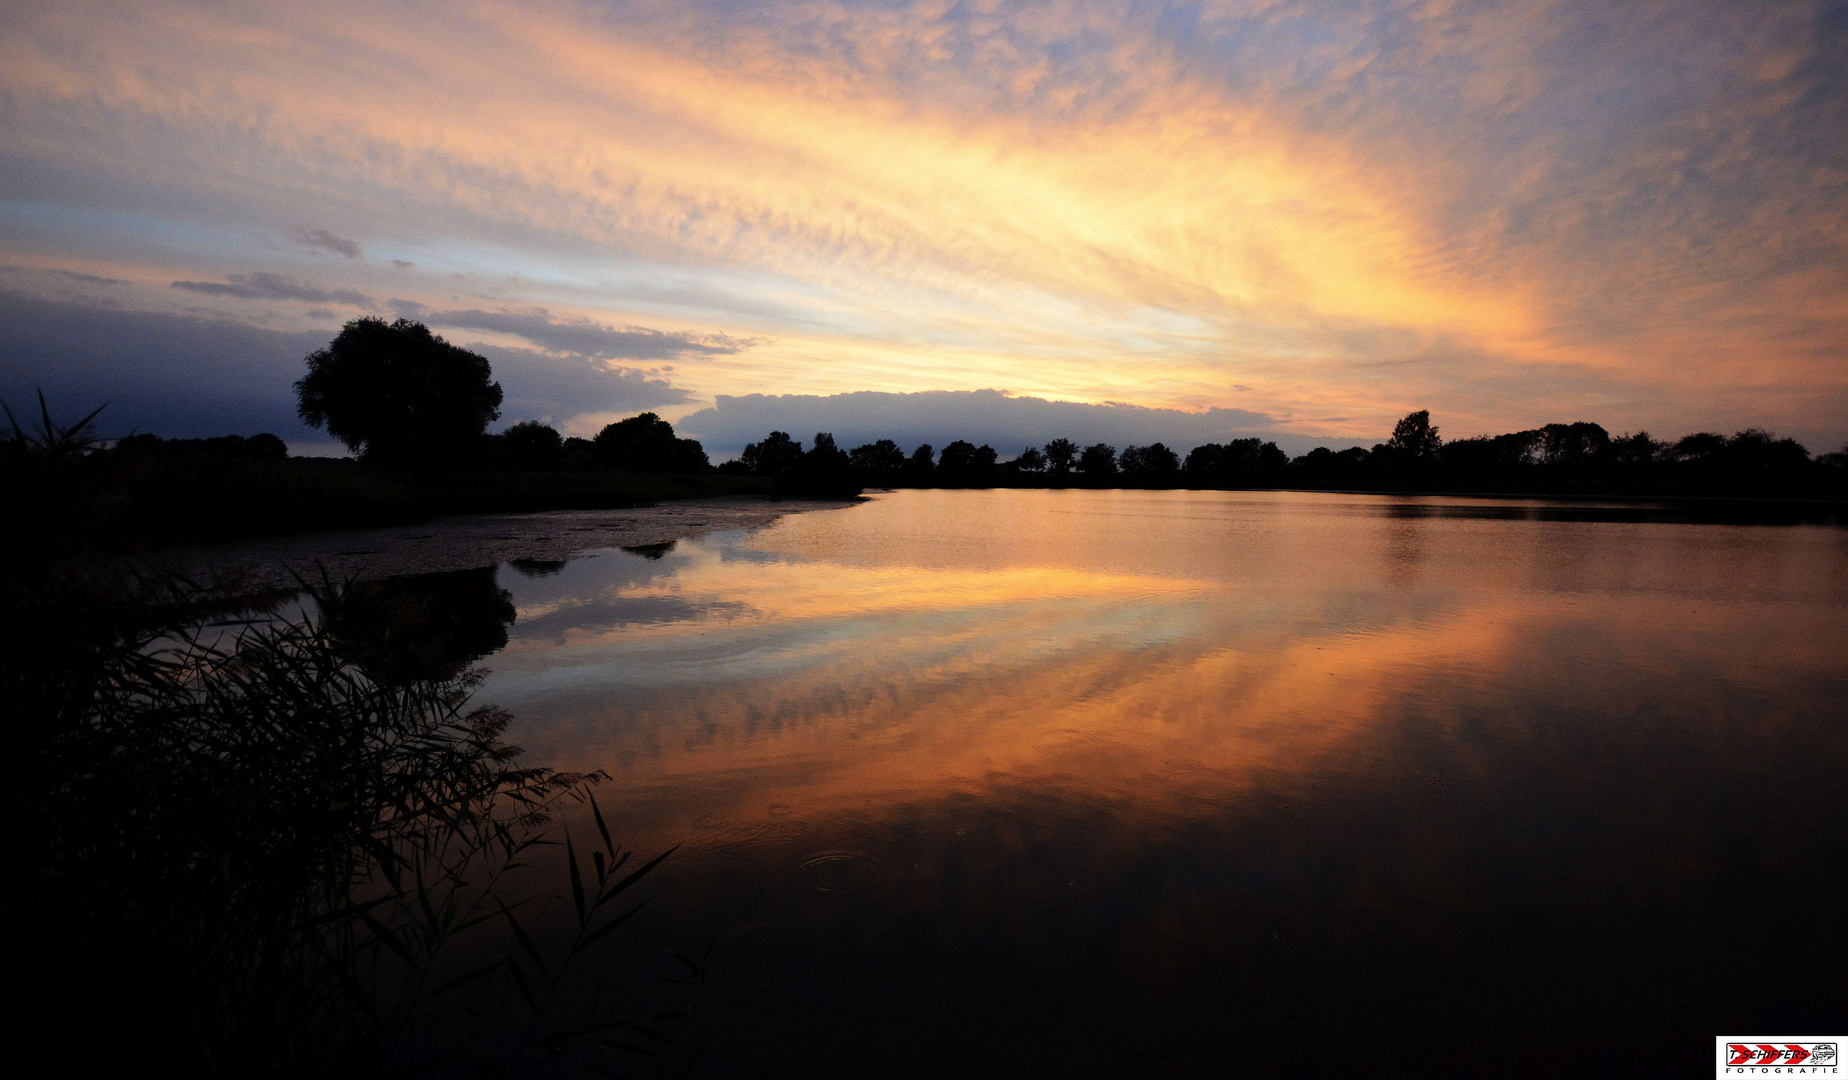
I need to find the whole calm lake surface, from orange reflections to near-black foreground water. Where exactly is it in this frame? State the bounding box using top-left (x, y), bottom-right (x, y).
top-left (469, 492), bottom-right (1848, 1076)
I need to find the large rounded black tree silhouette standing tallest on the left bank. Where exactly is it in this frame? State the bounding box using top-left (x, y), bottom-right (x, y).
top-left (296, 318), bottom-right (501, 466)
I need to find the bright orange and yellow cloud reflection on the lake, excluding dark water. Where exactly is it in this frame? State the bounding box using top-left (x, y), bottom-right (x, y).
top-left (490, 492), bottom-right (1839, 843)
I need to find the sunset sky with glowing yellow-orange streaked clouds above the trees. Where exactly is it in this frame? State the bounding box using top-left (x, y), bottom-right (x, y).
top-left (0, 0), bottom-right (1848, 453)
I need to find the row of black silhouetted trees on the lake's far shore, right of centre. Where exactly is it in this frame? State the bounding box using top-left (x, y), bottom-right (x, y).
top-left (719, 411), bottom-right (1848, 499)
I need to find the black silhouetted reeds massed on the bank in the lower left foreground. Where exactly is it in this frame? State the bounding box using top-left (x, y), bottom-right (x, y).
top-left (0, 570), bottom-right (694, 1074)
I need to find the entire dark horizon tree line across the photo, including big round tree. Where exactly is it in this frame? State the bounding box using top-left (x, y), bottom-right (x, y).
top-left (14, 318), bottom-right (1848, 494)
